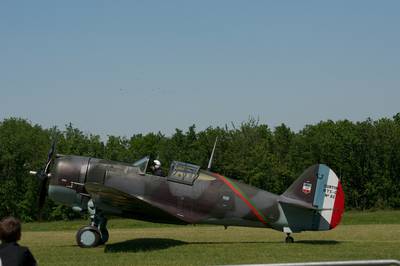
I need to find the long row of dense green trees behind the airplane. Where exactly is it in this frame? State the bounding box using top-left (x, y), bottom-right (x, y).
top-left (0, 113), bottom-right (400, 221)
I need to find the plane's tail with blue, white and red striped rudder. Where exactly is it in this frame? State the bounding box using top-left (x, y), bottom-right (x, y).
top-left (280, 164), bottom-right (344, 231)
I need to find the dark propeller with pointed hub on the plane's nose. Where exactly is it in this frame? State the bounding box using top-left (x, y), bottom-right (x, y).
top-left (29, 141), bottom-right (56, 218)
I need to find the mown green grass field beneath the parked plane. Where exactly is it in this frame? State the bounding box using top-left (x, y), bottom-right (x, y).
top-left (21, 211), bottom-right (400, 266)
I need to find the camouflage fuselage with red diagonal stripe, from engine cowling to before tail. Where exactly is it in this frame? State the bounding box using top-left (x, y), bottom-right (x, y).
top-left (49, 156), bottom-right (280, 227)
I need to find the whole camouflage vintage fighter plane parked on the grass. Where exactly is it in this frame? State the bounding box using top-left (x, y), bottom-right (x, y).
top-left (31, 144), bottom-right (344, 247)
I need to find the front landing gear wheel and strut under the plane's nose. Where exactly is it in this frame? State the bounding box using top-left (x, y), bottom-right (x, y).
top-left (76, 200), bottom-right (109, 248)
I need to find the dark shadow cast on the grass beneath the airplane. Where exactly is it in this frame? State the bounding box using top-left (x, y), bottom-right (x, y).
top-left (104, 238), bottom-right (340, 253)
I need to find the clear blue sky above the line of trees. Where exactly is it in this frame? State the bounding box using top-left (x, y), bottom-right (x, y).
top-left (0, 0), bottom-right (400, 137)
